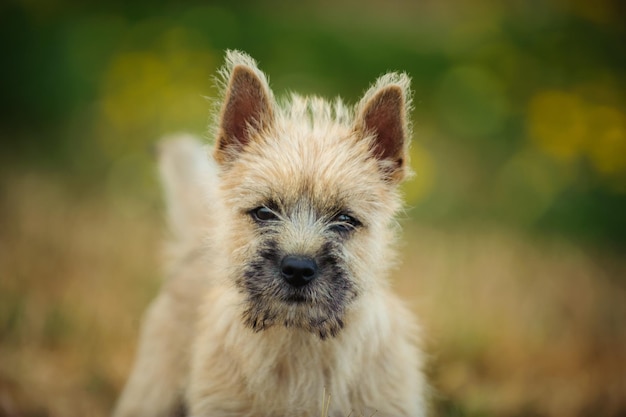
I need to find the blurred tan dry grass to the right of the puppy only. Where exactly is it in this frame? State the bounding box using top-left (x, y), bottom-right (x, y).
top-left (397, 229), bottom-right (626, 417)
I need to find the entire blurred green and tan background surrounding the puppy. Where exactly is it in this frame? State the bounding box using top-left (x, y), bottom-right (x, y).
top-left (0, 0), bottom-right (626, 416)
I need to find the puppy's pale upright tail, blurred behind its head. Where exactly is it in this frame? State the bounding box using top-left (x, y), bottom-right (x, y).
top-left (157, 134), bottom-right (217, 246)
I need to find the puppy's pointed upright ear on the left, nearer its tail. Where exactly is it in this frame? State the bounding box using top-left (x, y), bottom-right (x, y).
top-left (214, 51), bottom-right (274, 164)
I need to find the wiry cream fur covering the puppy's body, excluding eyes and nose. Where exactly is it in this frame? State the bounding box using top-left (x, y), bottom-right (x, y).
top-left (114, 52), bottom-right (425, 417)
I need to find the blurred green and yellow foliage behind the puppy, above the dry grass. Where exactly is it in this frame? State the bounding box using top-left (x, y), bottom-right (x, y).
top-left (0, 0), bottom-right (626, 240)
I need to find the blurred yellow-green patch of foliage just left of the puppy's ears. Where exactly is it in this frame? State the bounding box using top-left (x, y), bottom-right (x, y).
top-left (100, 25), bottom-right (216, 157)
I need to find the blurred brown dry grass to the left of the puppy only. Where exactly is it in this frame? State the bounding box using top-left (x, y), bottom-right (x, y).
top-left (0, 173), bottom-right (161, 416)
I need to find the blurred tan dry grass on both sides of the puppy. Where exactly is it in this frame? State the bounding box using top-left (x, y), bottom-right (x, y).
top-left (0, 170), bottom-right (626, 417)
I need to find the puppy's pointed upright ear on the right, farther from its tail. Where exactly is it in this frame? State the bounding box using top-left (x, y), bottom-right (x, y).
top-left (356, 73), bottom-right (411, 183)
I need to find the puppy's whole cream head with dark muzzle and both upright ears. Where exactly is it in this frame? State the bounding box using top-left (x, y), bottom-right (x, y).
top-left (215, 54), bottom-right (407, 338)
